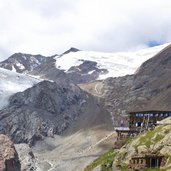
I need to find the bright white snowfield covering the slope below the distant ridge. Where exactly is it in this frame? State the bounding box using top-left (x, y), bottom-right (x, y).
top-left (56, 43), bottom-right (169, 79)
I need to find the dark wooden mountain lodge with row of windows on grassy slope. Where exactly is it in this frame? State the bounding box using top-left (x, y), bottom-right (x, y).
top-left (114, 110), bottom-right (171, 149)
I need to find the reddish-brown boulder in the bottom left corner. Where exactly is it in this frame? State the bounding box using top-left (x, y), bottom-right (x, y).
top-left (0, 134), bottom-right (20, 171)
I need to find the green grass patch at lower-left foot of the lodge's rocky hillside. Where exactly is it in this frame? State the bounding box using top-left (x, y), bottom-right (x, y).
top-left (84, 149), bottom-right (117, 171)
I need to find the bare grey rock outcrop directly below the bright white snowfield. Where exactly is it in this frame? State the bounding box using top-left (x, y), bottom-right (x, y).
top-left (26, 58), bottom-right (108, 84)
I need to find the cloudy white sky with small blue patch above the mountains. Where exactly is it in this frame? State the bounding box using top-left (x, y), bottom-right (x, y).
top-left (0, 0), bottom-right (171, 60)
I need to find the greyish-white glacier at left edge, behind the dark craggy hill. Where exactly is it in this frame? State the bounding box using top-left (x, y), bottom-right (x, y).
top-left (0, 68), bottom-right (40, 109)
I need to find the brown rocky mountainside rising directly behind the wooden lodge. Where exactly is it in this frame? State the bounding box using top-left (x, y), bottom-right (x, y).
top-left (103, 46), bottom-right (171, 125)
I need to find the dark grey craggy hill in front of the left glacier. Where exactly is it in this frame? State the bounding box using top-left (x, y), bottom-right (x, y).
top-left (0, 81), bottom-right (112, 145)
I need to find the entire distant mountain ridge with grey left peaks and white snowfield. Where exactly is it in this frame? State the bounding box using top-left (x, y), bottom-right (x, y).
top-left (0, 43), bottom-right (169, 84)
